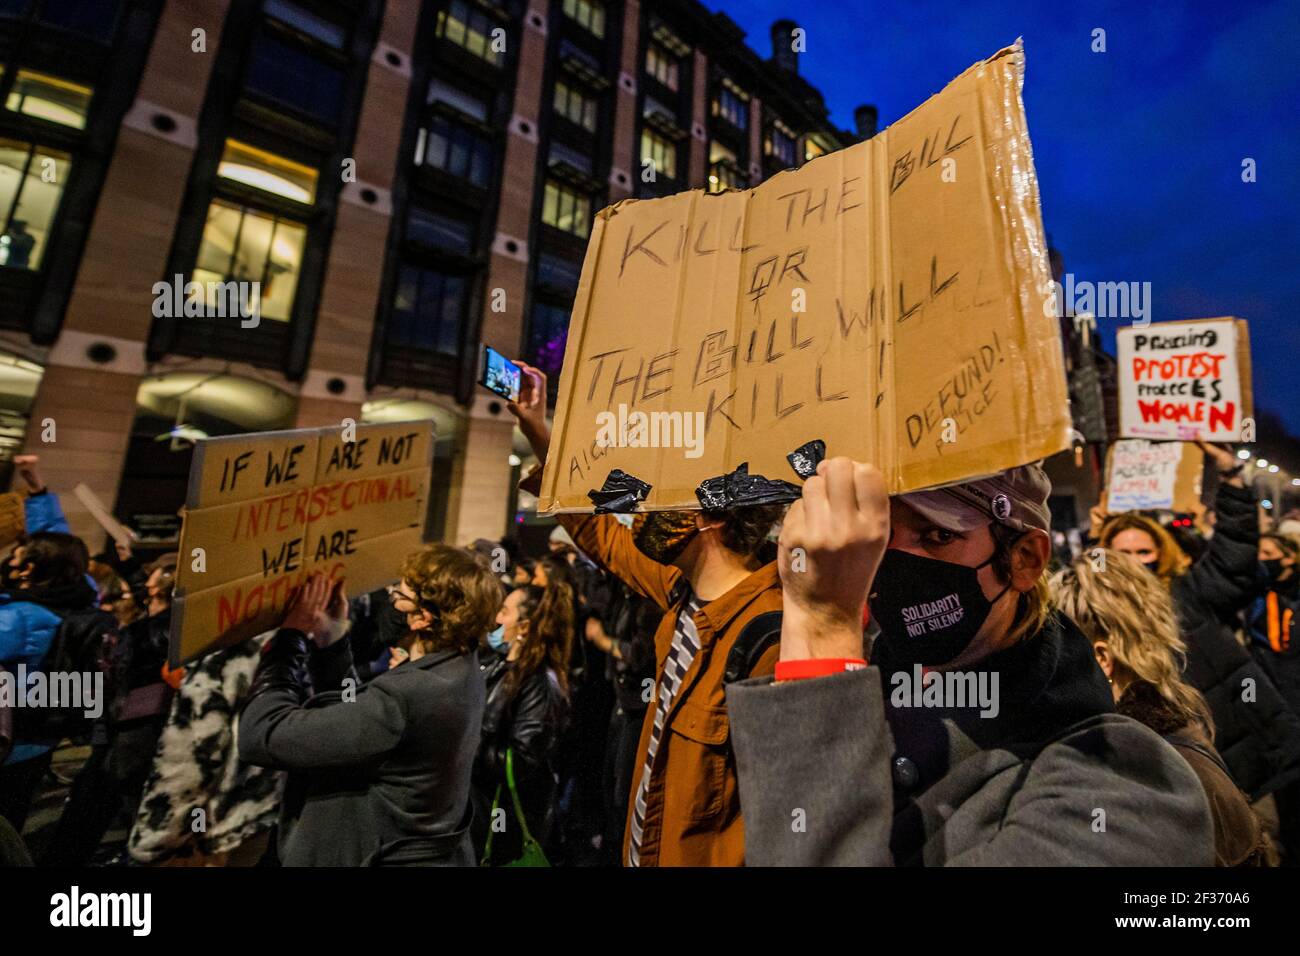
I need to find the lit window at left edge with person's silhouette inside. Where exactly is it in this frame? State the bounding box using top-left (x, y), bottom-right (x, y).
top-left (0, 139), bottom-right (72, 269)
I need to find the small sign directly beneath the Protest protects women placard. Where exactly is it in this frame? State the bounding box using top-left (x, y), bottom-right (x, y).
top-left (1106, 438), bottom-right (1204, 514)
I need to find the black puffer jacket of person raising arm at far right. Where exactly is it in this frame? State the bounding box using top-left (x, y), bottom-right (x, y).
top-left (1170, 484), bottom-right (1300, 800)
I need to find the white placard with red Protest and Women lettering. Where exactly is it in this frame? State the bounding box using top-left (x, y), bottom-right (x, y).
top-left (1115, 316), bottom-right (1252, 441)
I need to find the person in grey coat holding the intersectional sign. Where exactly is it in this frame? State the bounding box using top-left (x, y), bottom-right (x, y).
top-left (239, 545), bottom-right (501, 866)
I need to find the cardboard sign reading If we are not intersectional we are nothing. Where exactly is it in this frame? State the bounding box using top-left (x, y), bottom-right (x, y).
top-left (170, 421), bottom-right (433, 666)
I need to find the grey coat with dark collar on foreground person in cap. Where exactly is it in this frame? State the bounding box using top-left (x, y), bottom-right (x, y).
top-left (727, 615), bottom-right (1214, 866)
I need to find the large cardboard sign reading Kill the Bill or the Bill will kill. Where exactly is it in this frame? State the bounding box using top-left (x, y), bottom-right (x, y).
top-left (540, 44), bottom-right (1071, 512)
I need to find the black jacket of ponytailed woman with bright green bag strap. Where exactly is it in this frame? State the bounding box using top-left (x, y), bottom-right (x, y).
top-left (473, 649), bottom-right (569, 861)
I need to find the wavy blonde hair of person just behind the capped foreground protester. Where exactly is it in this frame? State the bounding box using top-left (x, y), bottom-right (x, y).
top-left (1050, 550), bottom-right (1214, 740)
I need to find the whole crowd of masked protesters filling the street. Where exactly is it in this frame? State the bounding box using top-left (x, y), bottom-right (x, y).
top-left (0, 356), bottom-right (1300, 866)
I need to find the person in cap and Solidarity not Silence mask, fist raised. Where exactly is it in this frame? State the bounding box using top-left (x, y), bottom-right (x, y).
top-left (728, 458), bottom-right (1213, 866)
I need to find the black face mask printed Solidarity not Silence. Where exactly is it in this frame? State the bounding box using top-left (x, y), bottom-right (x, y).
top-left (870, 548), bottom-right (1011, 667)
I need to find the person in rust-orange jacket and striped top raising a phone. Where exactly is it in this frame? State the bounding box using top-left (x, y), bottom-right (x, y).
top-left (508, 363), bottom-right (781, 866)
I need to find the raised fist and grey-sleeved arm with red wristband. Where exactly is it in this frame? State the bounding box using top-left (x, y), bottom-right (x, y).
top-left (727, 458), bottom-right (893, 866)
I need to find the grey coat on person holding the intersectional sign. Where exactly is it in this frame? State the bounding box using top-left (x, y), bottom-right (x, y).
top-left (239, 630), bottom-right (486, 866)
